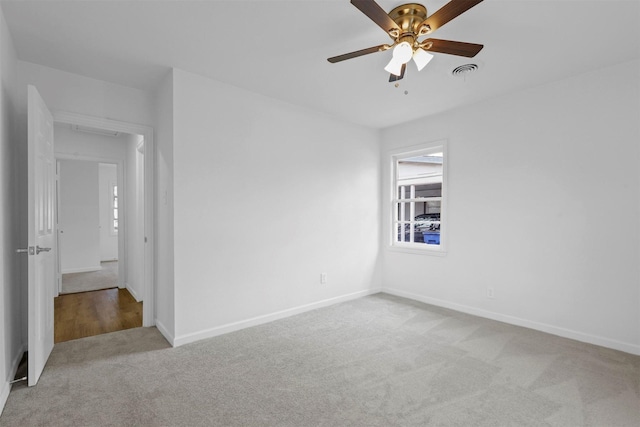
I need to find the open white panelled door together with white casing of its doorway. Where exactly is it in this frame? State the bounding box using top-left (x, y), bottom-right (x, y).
top-left (23, 85), bottom-right (155, 386)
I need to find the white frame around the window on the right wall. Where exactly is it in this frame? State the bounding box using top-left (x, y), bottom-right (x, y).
top-left (387, 140), bottom-right (449, 256)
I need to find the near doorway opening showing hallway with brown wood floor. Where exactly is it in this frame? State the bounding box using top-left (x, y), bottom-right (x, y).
top-left (54, 123), bottom-right (144, 343)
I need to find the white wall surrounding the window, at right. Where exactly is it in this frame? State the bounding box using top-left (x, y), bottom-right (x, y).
top-left (383, 61), bottom-right (640, 354)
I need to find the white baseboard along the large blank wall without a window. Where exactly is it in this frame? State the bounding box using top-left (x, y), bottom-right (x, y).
top-left (174, 289), bottom-right (380, 347)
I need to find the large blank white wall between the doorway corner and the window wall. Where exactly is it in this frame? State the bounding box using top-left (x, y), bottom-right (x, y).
top-left (172, 70), bottom-right (380, 344)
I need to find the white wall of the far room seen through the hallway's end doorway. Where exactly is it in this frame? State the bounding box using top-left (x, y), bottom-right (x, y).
top-left (58, 160), bottom-right (101, 274)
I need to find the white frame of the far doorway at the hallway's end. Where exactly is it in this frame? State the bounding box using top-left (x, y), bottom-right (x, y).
top-left (53, 155), bottom-right (125, 296)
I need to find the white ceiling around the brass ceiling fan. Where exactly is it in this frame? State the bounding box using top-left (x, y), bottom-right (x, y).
top-left (1, 0), bottom-right (640, 128)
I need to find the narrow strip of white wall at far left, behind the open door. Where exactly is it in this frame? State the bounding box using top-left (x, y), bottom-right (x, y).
top-left (0, 3), bottom-right (22, 413)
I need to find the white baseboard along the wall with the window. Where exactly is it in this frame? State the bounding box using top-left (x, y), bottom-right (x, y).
top-left (381, 287), bottom-right (640, 355)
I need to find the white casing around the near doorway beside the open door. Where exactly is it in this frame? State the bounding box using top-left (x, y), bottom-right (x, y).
top-left (52, 110), bottom-right (156, 326)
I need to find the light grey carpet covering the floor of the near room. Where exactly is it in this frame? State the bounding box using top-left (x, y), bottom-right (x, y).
top-left (0, 294), bottom-right (640, 427)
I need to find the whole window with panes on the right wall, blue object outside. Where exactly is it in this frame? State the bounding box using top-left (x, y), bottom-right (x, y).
top-left (391, 142), bottom-right (446, 252)
